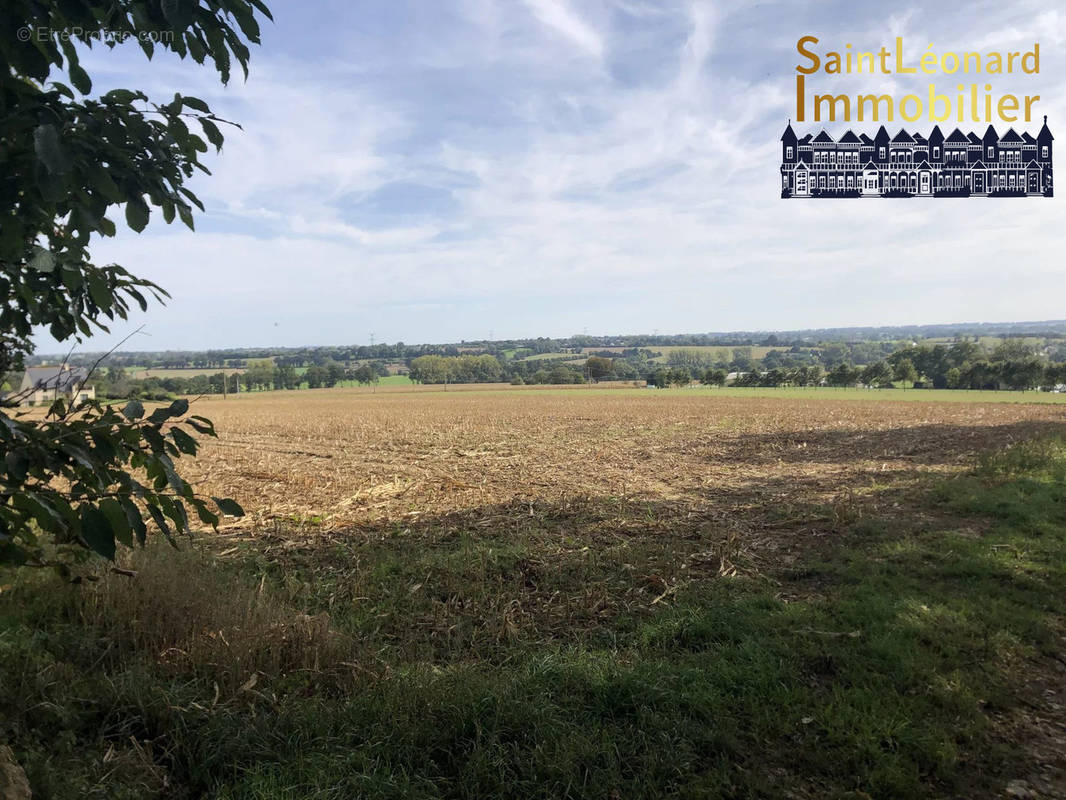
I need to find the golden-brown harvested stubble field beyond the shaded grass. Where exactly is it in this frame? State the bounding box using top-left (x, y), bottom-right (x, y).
top-left (185, 389), bottom-right (1066, 541)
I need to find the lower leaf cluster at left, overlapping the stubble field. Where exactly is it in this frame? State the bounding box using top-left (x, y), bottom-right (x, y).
top-left (0, 398), bottom-right (244, 565)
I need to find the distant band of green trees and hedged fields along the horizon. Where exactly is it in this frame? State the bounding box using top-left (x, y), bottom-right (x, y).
top-left (31, 336), bottom-right (1066, 399)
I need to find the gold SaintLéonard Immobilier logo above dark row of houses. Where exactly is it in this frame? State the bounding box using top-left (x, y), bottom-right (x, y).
top-left (781, 36), bottom-right (1054, 198)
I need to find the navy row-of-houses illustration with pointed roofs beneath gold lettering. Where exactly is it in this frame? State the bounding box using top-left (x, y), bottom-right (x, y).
top-left (781, 116), bottom-right (1054, 197)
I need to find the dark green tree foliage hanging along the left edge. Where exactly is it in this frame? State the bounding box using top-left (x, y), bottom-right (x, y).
top-left (0, 0), bottom-right (270, 565)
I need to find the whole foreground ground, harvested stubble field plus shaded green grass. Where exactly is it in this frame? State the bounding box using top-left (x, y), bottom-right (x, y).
top-left (0, 385), bottom-right (1066, 799)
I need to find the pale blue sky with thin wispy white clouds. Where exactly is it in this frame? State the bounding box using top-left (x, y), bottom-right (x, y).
top-left (38, 0), bottom-right (1066, 352)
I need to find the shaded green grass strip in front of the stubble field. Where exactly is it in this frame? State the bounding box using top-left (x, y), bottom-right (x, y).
top-left (0, 435), bottom-right (1066, 800)
